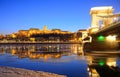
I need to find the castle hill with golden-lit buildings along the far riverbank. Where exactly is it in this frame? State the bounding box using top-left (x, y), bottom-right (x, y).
top-left (0, 25), bottom-right (87, 43)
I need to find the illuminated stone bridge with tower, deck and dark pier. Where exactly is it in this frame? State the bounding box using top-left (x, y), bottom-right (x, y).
top-left (83, 6), bottom-right (120, 51)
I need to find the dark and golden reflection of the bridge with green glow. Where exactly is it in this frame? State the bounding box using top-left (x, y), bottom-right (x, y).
top-left (87, 55), bottom-right (120, 77)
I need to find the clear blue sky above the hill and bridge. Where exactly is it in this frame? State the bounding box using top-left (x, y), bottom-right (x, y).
top-left (0, 0), bottom-right (120, 34)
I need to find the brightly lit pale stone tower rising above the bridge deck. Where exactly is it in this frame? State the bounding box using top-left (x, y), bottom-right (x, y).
top-left (89, 6), bottom-right (114, 33)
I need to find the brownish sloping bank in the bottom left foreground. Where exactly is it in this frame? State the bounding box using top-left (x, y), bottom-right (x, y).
top-left (0, 66), bottom-right (66, 77)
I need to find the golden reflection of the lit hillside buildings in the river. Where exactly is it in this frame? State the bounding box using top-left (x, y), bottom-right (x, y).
top-left (0, 44), bottom-right (82, 61)
